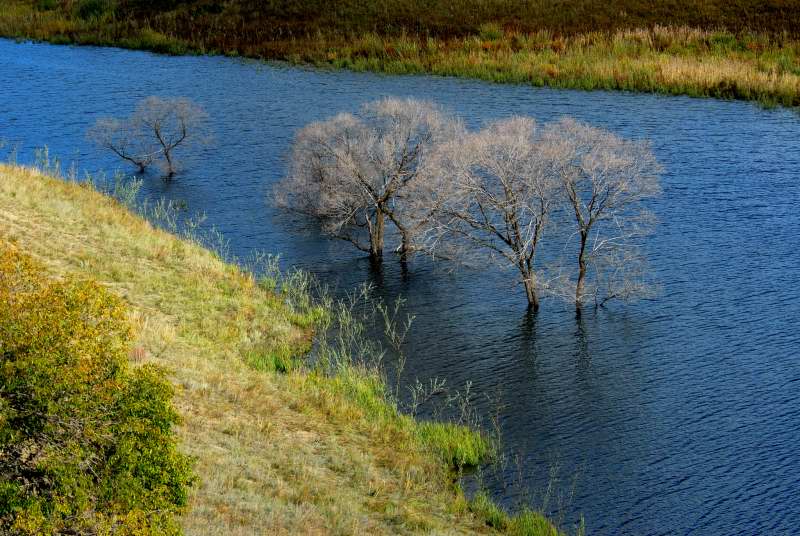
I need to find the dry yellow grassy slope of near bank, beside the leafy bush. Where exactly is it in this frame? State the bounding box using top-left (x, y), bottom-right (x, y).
top-left (0, 165), bottom-right (557, 535)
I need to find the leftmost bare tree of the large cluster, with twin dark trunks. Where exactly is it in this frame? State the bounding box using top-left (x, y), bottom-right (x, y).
top-left (274, 98), bottom-right (461, 260)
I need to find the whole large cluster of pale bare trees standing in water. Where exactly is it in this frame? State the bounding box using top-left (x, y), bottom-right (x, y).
top-left (274, 98), bottom-right (661, 311)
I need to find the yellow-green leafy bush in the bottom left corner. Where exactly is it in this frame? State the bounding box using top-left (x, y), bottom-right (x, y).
top-left (0, 241), bottom-right (192, 535)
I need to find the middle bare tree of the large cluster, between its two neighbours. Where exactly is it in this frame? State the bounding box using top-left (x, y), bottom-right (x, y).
top-left (425, 117), bottom-right (559, 310)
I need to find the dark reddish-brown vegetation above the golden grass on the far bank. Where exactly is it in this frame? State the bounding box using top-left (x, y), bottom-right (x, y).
top-left (42, 0), bottom-right (800, 43)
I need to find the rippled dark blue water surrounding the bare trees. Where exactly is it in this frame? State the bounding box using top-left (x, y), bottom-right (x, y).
top-left (0, 40), bottom-right (800, 535)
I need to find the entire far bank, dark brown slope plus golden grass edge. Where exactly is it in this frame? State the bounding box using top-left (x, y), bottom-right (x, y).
top-left (0, 0), bottom-right (800, 107)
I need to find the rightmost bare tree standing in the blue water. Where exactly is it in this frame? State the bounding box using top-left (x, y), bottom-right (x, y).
top-left (541, 119), bottom-right (661, 312)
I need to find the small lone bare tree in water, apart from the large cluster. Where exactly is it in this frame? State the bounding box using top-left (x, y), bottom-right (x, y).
top-left (88, 97), bottom-right (208, 178)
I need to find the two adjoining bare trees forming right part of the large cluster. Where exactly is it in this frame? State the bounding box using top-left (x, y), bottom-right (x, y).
top-left (422, 117), bottom-right (661, 311)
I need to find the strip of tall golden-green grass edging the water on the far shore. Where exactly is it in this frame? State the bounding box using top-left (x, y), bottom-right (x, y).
top-left (320, 25), bottom-right (800, 107)
